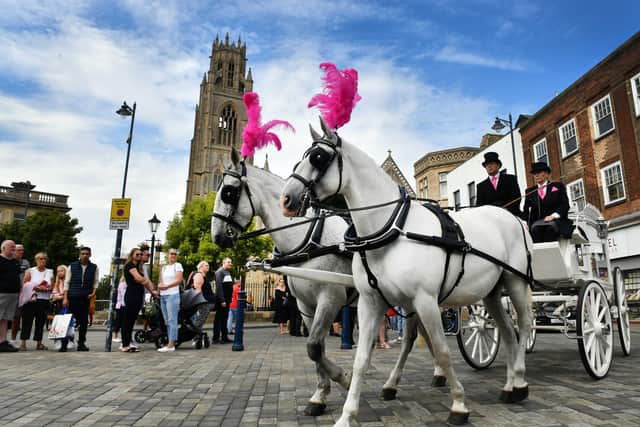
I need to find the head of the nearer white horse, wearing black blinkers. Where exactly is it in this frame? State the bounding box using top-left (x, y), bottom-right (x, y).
top-left (280, 117), bottom-right (342, 217)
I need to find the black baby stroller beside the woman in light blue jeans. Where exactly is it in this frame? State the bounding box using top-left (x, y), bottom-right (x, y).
top-left (155, 289), bottom-right (211, 350)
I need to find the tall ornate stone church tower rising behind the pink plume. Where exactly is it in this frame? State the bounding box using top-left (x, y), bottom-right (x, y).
top-left (186, 33), bottom-right (253, 203)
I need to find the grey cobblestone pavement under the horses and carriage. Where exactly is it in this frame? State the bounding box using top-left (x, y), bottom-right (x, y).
top-left (0, 325), bottom-right (640, 426)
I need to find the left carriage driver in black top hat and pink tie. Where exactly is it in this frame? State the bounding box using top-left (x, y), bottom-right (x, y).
top-left (476, 151), bottom-right (521, 216)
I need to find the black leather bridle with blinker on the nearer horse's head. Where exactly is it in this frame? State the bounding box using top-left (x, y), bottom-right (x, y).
top-left (289, 135), bottom-right (343, 213)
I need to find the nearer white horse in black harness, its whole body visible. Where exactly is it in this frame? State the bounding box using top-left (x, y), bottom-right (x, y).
top-left (280, 120), bottom-right (532, 426)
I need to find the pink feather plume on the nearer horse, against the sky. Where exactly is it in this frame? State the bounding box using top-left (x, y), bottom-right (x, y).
top-left (307, 62), bottom-right (362, 129)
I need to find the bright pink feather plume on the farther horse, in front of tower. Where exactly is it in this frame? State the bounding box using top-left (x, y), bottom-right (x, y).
top-left (242, 92), bottom-right (295, 156)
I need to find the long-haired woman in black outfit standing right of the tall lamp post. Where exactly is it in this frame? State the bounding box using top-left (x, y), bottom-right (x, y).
top-left (120, 248), bottom-right (158, 353)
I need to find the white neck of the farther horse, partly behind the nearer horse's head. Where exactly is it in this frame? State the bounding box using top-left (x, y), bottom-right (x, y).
top-left (247, 166), bottom-right (316, 252)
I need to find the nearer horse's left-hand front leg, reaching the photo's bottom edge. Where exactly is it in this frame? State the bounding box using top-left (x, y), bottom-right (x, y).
top-left (335, 293), bottom-right (385, 427)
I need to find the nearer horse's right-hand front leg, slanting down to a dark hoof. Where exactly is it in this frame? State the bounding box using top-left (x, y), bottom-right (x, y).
top-left (415, 295), bottom-right (469, 425)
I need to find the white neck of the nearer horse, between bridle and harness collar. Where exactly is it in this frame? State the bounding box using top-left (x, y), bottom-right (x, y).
top-left (340, 140), bottom-right (400, 236)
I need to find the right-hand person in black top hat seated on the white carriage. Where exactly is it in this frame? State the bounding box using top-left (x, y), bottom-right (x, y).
top-left (522, 162), bottom-right (573, 243)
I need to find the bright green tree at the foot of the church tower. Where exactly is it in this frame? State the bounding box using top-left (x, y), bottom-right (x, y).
top-left (165, 193), bottom-right (273, 280)
